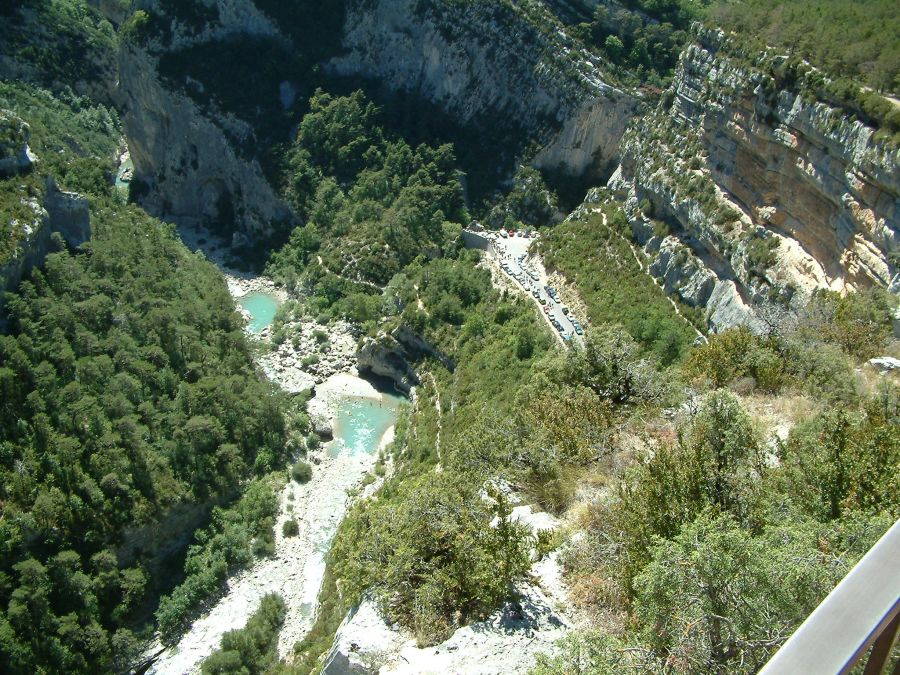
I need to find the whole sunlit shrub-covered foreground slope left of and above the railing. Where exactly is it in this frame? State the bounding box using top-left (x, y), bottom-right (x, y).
top-left (535, 293), bottom-right (900, 675)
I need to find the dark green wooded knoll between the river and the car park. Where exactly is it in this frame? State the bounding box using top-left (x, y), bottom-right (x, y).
top-left (267, 92), bottom-right (471, 323)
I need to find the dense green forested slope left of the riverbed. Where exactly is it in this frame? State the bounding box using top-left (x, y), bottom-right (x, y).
top-left (0, 83), bottom-right (288, 673)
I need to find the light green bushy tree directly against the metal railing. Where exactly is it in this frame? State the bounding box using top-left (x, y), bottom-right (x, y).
top-left (634, 511), bottom-right (884, 673)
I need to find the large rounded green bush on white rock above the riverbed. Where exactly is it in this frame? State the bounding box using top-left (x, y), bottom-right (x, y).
top-left (332, 471), bottom-right (530, 645)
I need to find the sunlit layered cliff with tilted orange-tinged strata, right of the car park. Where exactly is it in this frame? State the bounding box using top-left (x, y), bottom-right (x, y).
top-left (609, 31), bottom-right (900, 329)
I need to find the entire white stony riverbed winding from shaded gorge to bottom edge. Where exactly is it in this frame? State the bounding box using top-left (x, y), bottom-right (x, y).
top-left (148, 227), bottom-right (395, 675)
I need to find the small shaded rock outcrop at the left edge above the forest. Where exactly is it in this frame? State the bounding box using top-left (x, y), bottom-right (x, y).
top-left (0, 178), bottom-right (91, 324)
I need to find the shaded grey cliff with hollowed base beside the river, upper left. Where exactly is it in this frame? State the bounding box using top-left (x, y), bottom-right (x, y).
top-left (119, 0), bottom-right (291, 243)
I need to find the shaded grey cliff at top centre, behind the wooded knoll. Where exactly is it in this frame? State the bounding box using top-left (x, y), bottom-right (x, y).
top-left (329, 0), bottom-right (635, 180)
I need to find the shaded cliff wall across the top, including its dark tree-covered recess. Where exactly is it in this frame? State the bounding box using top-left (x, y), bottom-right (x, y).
top-left (112, 0), bottom-right (635, 243)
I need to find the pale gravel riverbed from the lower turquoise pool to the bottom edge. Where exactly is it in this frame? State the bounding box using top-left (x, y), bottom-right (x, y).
top-left (150, 373), bottom-right (394, 675)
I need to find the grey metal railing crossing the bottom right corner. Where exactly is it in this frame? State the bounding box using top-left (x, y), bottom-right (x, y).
top-left (759, 520), bottom-right (900, 675)
